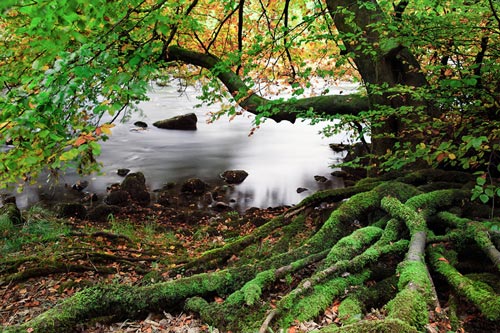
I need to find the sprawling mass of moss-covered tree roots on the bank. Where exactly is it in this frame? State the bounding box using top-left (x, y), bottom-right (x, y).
top-left (3, 170), bottom-right (500, 333)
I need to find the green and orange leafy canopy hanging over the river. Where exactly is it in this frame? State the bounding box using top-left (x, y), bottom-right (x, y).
top-left (0, 0), bottom-right (500, 195)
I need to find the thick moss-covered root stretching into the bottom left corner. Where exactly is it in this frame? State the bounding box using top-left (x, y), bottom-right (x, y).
top-left (4, 267), bottom-right (253, 333)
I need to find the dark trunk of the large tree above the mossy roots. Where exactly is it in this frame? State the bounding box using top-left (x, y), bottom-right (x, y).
top-left (326, 0), bottom-right (427, 167)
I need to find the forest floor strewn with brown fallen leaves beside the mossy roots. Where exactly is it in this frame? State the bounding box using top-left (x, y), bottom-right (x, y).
top-left (0, 198), bottom-right (496, 333)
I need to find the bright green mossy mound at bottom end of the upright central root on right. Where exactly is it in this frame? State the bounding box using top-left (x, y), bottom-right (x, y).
top-left (387, 288), bottom-right (429, 331)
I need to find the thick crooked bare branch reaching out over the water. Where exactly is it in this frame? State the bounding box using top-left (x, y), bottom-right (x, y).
top-left (163, 46), bottom-right (370, 122)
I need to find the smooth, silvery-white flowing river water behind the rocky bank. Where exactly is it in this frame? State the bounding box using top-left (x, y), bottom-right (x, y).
top-left (6, 82), bottom-right (354, 209)
